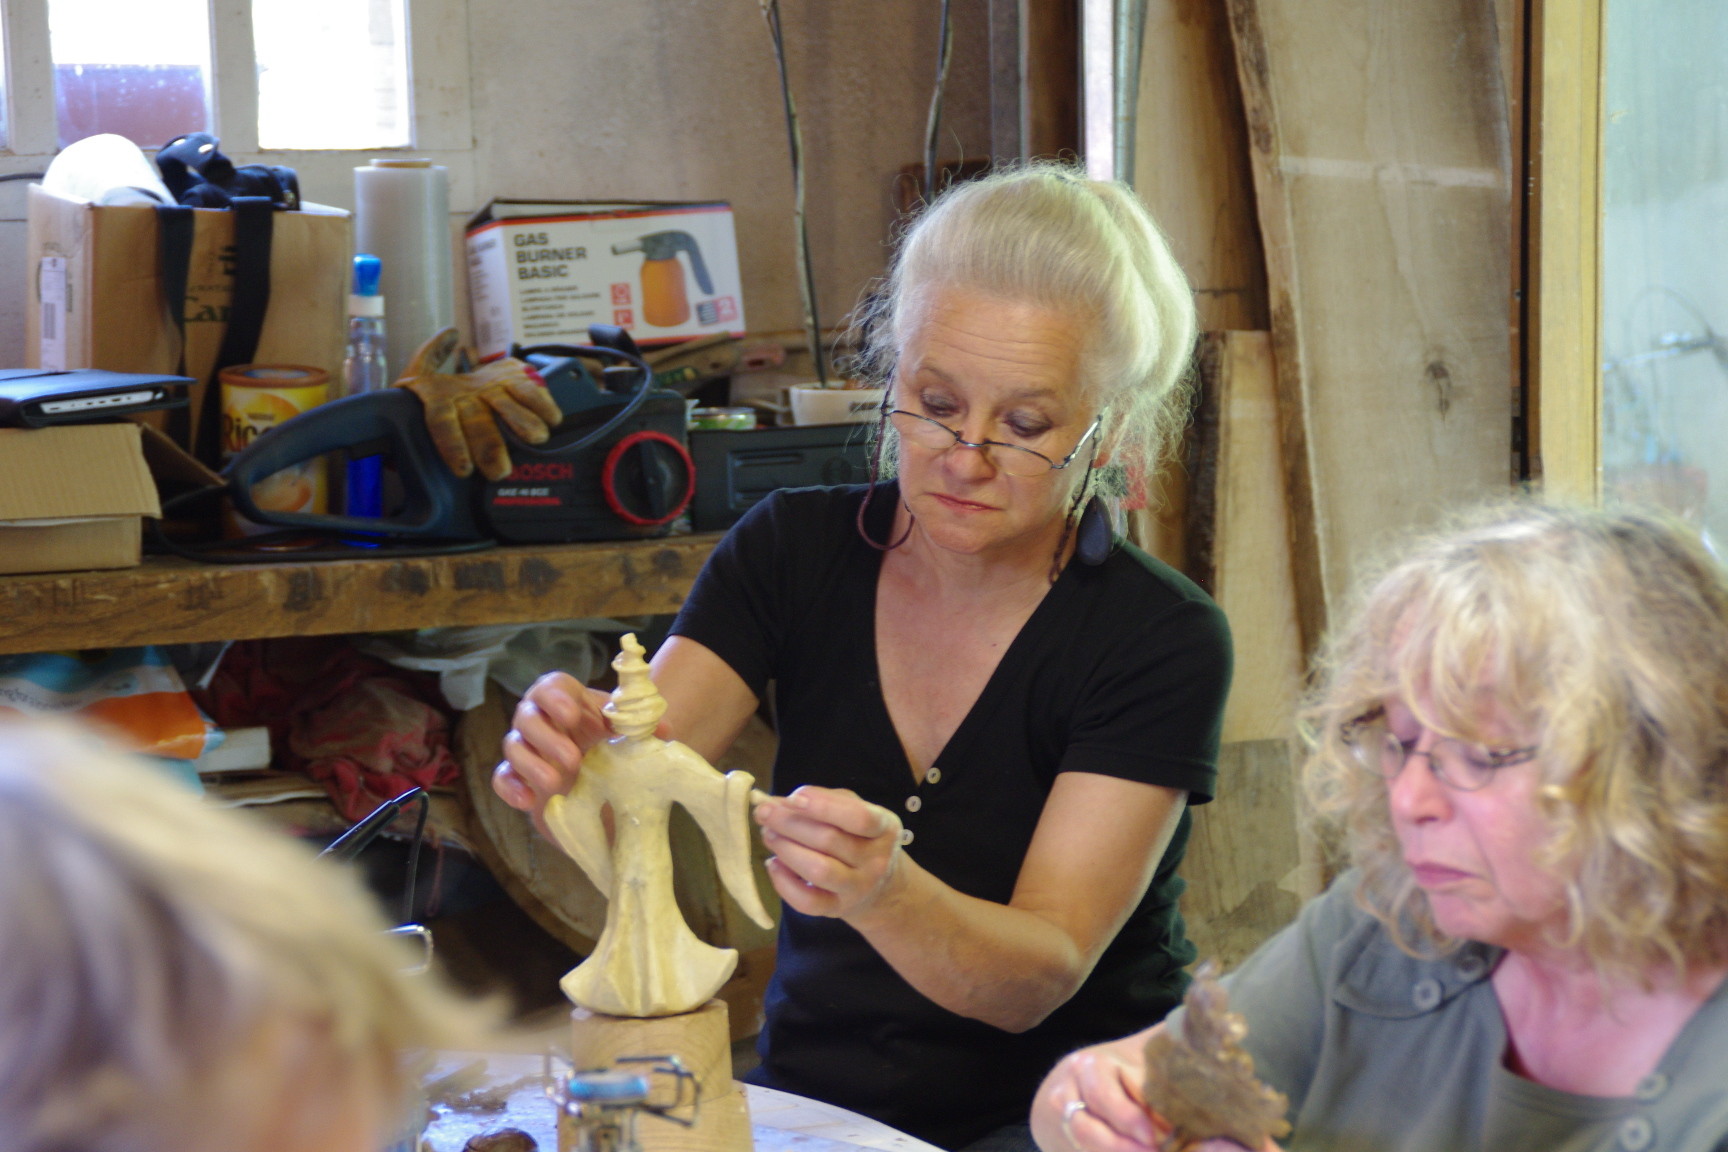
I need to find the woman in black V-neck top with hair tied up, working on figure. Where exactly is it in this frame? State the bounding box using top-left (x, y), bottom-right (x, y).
top-left (494, 166), bottom-right (1230, 1149)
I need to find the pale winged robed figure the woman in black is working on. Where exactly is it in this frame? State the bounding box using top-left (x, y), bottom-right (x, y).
top-left (546, 636), bottom-right (774, 1017)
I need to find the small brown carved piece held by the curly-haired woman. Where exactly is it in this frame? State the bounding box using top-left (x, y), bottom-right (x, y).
top-left (1144, 962), bottom-right (1291, 1149)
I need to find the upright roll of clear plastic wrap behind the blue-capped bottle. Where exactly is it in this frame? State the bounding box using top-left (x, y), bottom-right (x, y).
top-left (354, 161), bottom-right (456, 380)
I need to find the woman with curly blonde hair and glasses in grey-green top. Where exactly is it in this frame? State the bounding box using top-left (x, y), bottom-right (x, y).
top-left (1033, 504), bottom-right (1728, 1152)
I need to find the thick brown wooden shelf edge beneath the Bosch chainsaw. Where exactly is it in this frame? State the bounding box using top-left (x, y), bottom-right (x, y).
top-left (0, 534), bottom-right (721, 655)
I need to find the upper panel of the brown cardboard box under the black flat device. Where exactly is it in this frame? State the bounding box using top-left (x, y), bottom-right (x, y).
top-left (0, 423), bottom-right (162, 520)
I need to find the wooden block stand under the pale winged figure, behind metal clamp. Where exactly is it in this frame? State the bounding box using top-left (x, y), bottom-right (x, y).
top-left (558, 1000), bottom-right (752, 1152)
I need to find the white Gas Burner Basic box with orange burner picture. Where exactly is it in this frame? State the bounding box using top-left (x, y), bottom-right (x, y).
top-left (467, 200), bottom-right (745, 359)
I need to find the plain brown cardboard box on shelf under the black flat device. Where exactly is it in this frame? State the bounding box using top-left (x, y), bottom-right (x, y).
top-left (0, 423), bottom-right (162, 572)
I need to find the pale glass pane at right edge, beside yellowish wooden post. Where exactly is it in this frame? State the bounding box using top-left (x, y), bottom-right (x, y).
top-left (1600, 0), bottom-right (1728, 554)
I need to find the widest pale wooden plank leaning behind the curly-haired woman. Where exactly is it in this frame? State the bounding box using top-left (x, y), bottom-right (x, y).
top-left (1229, 0), bottom-right (1514, 651)
